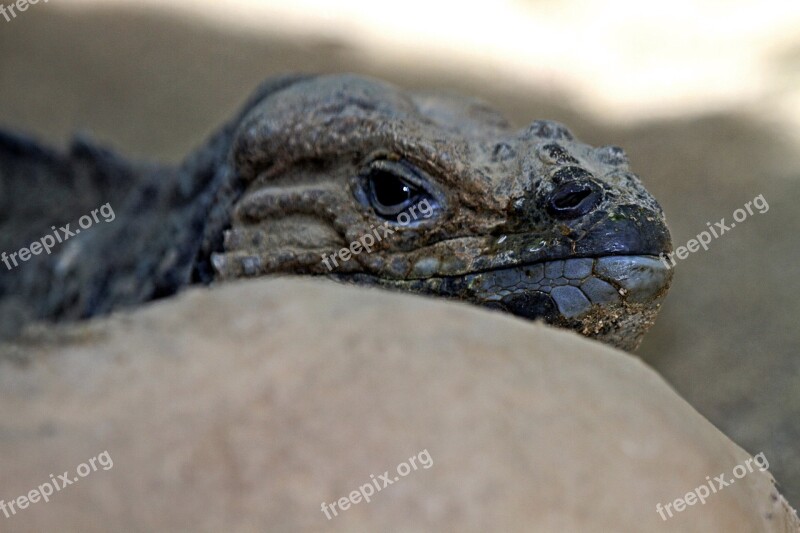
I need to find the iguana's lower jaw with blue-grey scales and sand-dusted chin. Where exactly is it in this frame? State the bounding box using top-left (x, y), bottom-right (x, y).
top-left (335, 255), bottom-right (672, 350)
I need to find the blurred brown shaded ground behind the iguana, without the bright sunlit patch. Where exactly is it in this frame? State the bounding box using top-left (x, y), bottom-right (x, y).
top-left (0, 2), bottom-right (800, 505)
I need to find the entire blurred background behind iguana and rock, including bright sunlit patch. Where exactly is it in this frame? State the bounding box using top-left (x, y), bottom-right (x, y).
top-left (0, 0), bottom-right (800, 507)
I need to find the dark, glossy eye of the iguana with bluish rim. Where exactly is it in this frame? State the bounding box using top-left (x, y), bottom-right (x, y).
top-left (365, 160), bottom-right (430, 221)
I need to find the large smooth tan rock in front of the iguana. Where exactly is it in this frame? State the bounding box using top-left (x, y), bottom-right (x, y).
top-left (0, 279), bottom-right (798, 532)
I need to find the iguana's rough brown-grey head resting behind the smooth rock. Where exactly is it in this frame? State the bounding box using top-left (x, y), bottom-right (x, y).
top-left (212, 76), bottom-right (671, 349)
